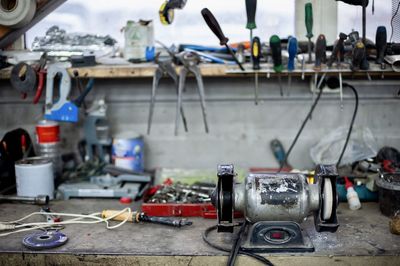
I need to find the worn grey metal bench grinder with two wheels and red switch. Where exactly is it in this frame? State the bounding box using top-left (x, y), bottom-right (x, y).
top-left (213, 165), bottom-right (339, 252)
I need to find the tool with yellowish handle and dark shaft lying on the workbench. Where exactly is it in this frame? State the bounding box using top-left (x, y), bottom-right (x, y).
top-left (101, 210), bottom-right (192, 227)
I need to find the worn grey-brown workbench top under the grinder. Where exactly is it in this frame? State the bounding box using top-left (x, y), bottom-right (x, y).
top-left (0, 199), bottom-right (400, 265)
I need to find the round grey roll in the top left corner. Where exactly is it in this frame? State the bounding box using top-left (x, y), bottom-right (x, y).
top-left (0, 0), bottom-right (36, 28)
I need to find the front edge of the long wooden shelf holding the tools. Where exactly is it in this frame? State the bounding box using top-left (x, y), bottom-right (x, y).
top-left (0, 63), bottom-right (400, 79)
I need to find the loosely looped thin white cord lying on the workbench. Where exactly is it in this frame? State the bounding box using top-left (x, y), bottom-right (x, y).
top-left (0, 208), bottom-right (132, 237)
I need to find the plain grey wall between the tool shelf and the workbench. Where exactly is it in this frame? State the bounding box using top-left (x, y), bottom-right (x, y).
top-left (0, 77), bottom-right (400, 169)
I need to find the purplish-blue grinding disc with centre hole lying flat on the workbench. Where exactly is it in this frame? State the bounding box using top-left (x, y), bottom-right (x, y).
top-left (22, 231), bottom-right (68, 250)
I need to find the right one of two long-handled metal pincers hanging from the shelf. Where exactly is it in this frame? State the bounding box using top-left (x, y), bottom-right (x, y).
top-left (175, 51), bottom-right (208, 135)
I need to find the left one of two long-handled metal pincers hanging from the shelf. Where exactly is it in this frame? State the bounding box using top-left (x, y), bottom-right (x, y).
top-left (147, 54), bottom-right (188, 134)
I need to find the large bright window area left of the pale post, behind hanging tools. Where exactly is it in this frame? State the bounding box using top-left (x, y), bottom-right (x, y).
top-left (27, 0), bottom-right (295, 47)
